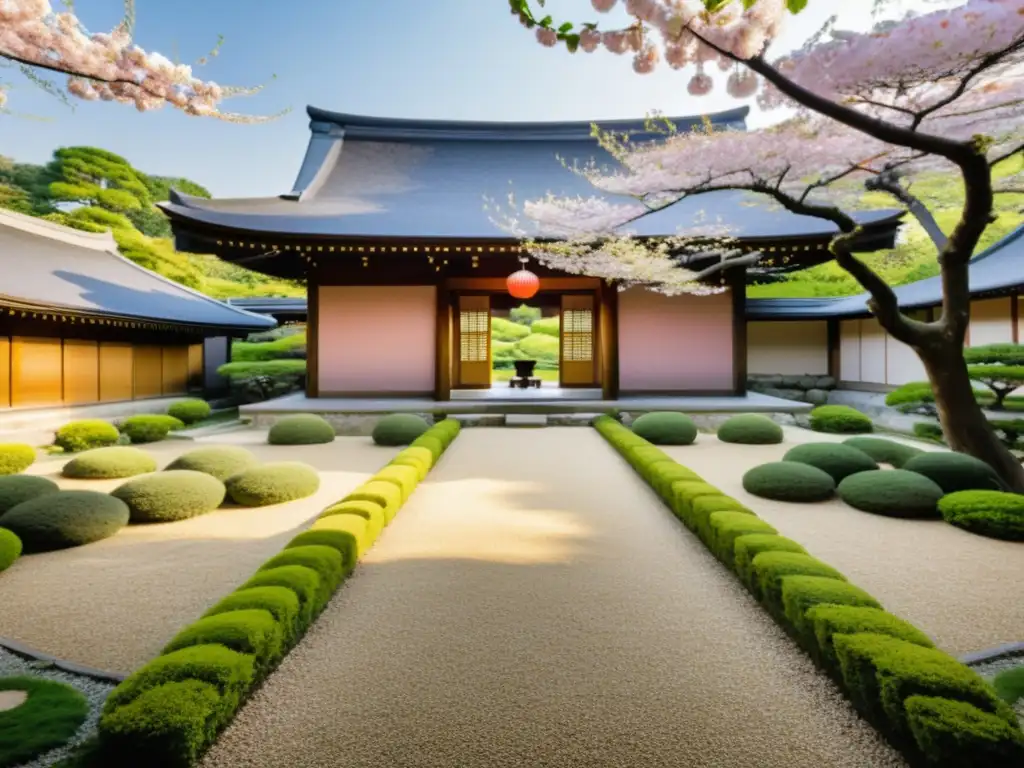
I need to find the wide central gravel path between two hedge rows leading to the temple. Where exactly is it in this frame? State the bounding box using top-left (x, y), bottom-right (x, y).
top-left (203, 427), bottom-right (902, 768)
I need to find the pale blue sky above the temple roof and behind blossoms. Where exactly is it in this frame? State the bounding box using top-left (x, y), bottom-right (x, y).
top-left (0, 0), bottom-right (888, 197)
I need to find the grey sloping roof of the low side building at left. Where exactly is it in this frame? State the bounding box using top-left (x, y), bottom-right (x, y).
top-left (0, 210), bottom-right (273, 331)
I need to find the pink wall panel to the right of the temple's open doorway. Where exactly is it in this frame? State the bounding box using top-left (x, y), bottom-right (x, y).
top-left (618, 288), bottom-right (734, 392)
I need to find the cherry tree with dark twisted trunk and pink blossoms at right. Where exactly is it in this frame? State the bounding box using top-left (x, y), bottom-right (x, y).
top-left (510, 0), bottom-right (1024, 493)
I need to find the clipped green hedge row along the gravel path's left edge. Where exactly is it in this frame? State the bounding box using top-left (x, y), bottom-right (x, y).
top-left (94, 419), bottom-right (460, 768)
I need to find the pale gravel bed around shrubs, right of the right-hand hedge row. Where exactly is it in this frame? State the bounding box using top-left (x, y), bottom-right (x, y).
top-left (665, 427), bottom-right (1024, 656)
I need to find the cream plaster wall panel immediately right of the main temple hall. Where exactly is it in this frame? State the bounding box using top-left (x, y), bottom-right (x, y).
top-left (746, 321), bottom-right (828, 376)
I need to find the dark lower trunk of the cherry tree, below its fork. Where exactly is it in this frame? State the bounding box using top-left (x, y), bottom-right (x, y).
top-left (920, 340), bottom-right (1024, 494)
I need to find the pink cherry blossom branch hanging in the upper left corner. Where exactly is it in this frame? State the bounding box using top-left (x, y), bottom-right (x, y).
top-left (0, 0), bottom-right (285, 123)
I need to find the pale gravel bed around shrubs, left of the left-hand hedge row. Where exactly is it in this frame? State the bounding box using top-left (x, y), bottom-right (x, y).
top-left (0, 431), bottom-right (395, 674)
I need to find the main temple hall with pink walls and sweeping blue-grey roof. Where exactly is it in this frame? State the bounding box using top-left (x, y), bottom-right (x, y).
top-left (161, 108), bottom-right (901, 400)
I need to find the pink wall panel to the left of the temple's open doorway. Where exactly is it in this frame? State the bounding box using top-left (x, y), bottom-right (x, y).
top-left (317, 286), bottom-right (437, 394)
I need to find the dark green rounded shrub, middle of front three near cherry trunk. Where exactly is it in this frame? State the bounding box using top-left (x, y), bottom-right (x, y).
top-left (838, 469), bottom-right (942, 518)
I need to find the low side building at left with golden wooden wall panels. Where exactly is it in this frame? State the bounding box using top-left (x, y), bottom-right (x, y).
top-left (0, 209), bottom-right (274, 416)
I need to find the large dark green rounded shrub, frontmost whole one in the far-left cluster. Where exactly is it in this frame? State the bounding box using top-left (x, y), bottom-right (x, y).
top-left (0, 490), bottom-right (128, 553)
